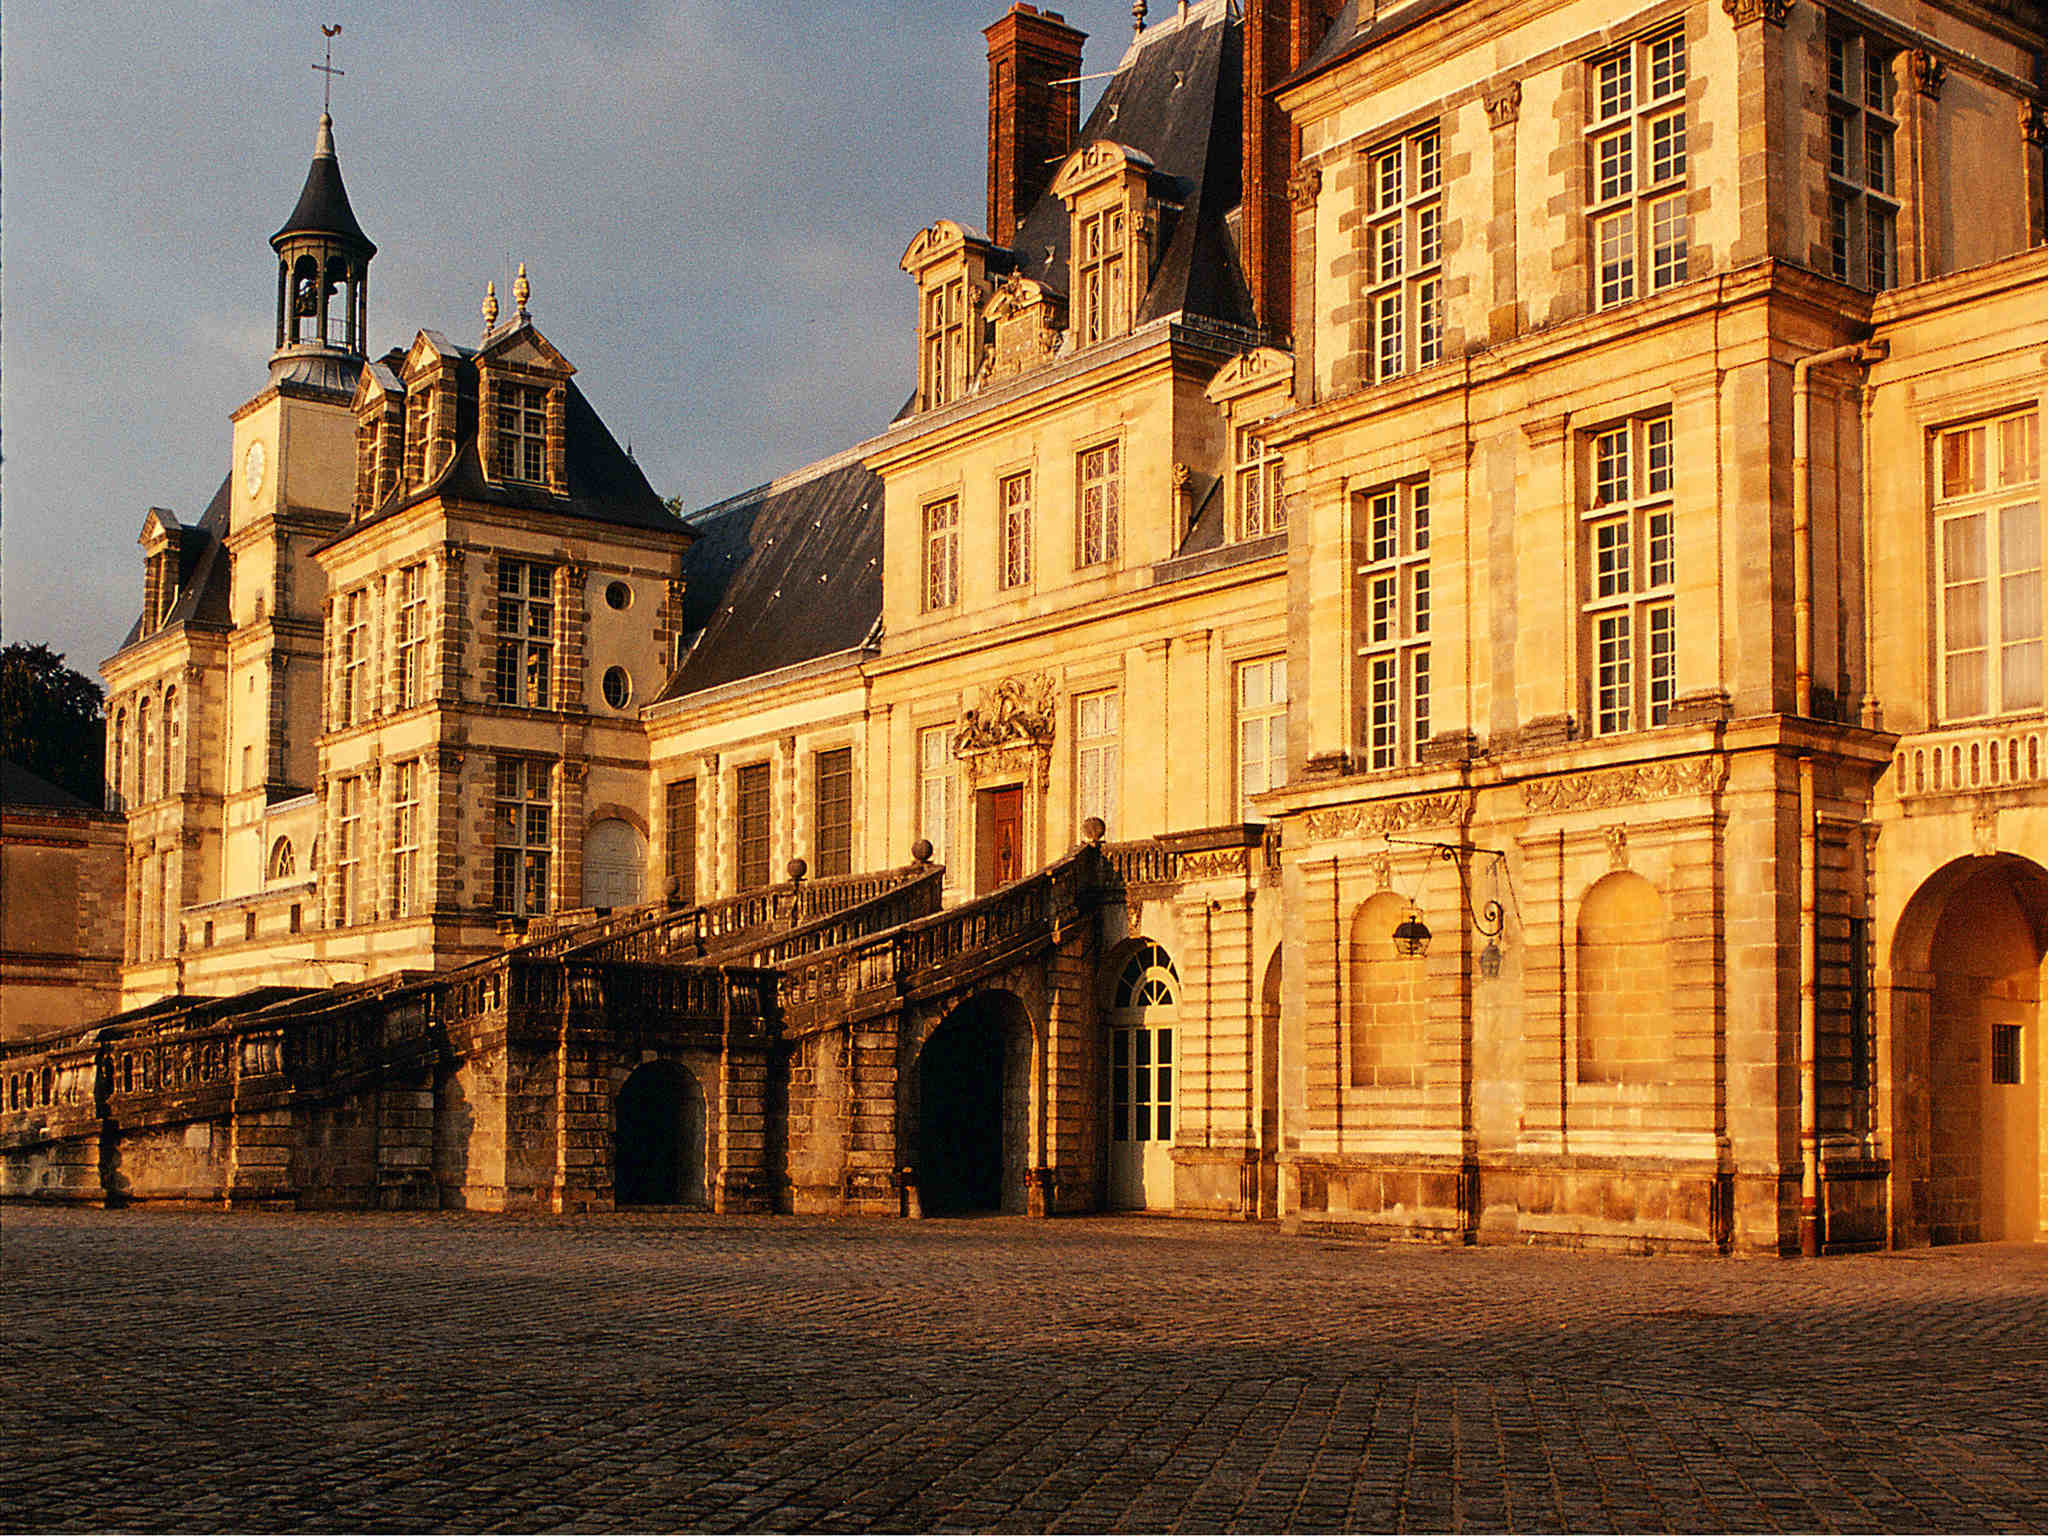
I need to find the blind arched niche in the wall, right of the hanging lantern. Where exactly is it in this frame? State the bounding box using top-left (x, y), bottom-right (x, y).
top-left (1575, 872), bottom-right (1675, 1083)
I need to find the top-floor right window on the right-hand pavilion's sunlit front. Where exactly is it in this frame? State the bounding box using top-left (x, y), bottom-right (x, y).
top-left (1587, 31), bottom-right (1688, 309)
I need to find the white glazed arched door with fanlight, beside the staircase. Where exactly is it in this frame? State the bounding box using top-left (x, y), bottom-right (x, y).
top-left (1110, 940), bottom-right (1180, 1210)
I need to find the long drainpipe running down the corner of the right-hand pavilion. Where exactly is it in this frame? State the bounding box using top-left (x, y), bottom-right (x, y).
top-left (1792, 340), bottom-right (1892, 1257)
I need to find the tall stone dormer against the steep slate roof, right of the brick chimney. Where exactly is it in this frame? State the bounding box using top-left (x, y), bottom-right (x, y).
top-left (1053, 139), bottom-right (1180, 346)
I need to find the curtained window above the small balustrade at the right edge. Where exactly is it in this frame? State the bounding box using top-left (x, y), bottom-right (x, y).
top-left (1927, 401), bottom-right (2048, 725)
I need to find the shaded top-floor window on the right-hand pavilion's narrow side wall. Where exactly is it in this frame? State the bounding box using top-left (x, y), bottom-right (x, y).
top-left (1827, 33), bottom-right (1898, 289)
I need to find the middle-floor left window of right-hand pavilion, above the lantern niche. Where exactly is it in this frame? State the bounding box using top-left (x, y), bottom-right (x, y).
top-left (1358, 479), bottom-right (1430, 772)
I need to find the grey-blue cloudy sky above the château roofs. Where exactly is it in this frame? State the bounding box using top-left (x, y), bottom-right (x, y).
top-left (0, 0), bottom-right (1138, 674)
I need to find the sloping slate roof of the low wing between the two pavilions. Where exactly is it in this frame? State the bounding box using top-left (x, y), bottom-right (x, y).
top-left (655, 459), bottom-right (883, 702)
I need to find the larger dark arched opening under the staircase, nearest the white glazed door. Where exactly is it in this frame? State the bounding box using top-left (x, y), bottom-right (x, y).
top-left (913, 991), bottom-right (1032, 1217)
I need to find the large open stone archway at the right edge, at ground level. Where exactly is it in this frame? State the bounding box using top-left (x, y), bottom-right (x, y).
top-left (1894, 856), bottom-right (2048, 1243)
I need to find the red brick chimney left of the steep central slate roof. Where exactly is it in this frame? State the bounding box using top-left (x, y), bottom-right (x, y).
top-left (983, 0), bottom-right (1087, 246)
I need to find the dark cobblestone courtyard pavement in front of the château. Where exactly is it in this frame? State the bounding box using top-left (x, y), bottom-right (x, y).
top-left (0, 1206), bottom-right (2048, 1530)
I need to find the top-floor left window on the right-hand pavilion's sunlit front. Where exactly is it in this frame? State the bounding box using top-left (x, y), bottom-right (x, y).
top-left (1366, 127), bottom-right (1444, 379)
